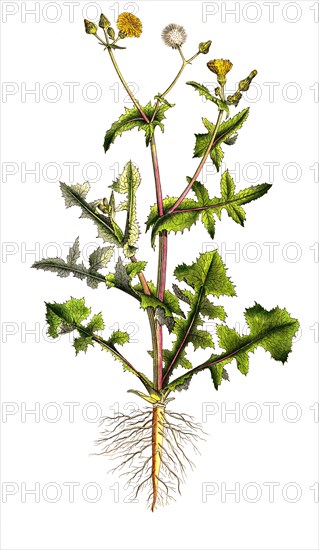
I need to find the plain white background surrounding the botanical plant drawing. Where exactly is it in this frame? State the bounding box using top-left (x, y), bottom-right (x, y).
top-left (1, 1), bottom-right (318, 550)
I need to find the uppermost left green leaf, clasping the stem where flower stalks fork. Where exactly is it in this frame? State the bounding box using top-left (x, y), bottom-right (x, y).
top-left (104, 102), bottom-right (171, 152)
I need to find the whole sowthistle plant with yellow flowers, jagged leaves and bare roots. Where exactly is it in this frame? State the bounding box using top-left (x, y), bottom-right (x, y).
top-left (33, 12), bottom-right (299, 510)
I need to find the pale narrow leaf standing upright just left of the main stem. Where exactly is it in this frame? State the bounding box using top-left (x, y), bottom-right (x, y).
top-left (111, 161), bottom-right (141, 258)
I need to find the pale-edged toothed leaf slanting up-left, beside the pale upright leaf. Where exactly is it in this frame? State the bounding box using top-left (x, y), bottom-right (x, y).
top-left (61, 183), bottom-right (123, 246)
